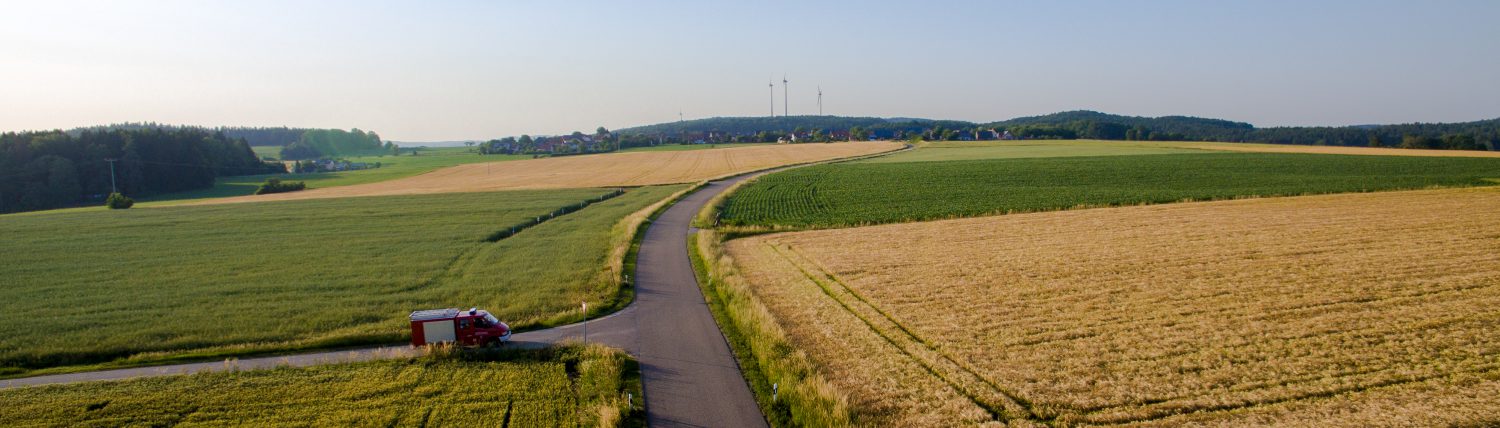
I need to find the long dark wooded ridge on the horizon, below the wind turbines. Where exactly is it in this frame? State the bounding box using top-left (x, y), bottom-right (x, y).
top-left (620, 111), bottom-right (1500, 150)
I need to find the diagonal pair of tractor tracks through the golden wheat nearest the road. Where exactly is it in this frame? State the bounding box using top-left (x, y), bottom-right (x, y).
top-left (767, 243), bottom-right (1046, 422)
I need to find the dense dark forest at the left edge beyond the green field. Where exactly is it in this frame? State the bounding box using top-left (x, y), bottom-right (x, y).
top-left (0, 128), bottom-right (287, 212)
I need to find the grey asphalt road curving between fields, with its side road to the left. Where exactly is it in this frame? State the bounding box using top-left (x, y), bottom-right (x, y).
top-left (0, 174), bottom-right (767, 426)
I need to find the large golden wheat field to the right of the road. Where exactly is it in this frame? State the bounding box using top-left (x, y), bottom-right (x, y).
top-left (728, 189), bottom-right (1500, 426)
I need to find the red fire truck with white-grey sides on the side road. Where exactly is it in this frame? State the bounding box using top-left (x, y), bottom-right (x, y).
top-left (411, 308), bottom-right (510, 347)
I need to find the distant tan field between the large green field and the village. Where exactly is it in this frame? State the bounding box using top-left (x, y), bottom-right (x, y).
top-left (193, 143), bottom-right (902, 204)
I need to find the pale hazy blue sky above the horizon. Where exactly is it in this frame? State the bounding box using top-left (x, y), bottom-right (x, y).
top-left (0, 0), bottom-right (1500, 141)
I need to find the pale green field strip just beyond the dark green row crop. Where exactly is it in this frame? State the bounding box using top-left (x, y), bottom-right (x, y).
top-left (858, 140), bottom-right (1205, 164)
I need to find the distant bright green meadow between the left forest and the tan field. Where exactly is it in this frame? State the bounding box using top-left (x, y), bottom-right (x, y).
top-left (140, 147), bottom-right (531, 206)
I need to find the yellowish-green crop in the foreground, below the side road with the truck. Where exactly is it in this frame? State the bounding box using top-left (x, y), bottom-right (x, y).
top-left (0, 347), bottom-right (641, 426)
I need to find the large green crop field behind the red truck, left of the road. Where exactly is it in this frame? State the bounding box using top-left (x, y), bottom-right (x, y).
top-left (0, 186), bottom-right (684, 375)
